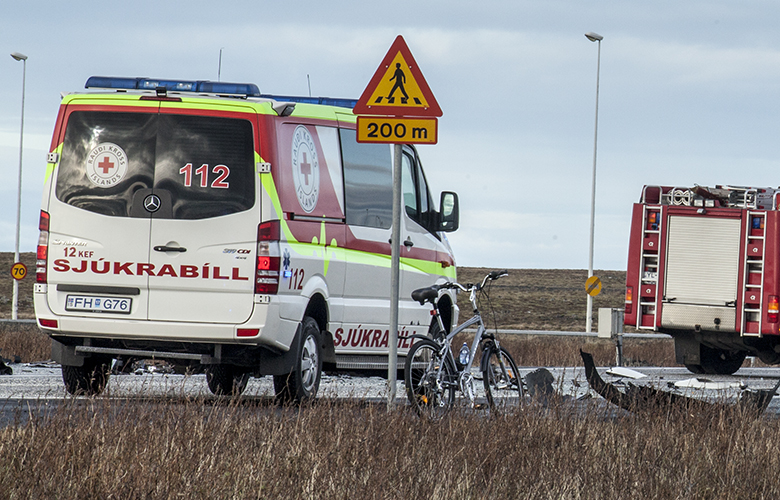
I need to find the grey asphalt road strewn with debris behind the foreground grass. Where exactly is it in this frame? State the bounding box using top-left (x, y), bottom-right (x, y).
top-left (0, 363), bottom-right (780, 427)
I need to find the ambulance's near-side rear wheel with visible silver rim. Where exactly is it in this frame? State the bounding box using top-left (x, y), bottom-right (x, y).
top-left (274, 316), bottom-right (322, 404)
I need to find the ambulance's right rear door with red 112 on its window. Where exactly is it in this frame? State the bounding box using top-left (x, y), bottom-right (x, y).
top-left (143, 105), bottom-right (260, 323)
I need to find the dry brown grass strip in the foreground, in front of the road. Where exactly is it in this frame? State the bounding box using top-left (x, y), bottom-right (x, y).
top-left (0, 399), bottom-right (780, 499)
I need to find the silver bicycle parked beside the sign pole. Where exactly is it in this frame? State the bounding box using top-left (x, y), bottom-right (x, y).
top-left (404, 270), bottom-right (525, 417)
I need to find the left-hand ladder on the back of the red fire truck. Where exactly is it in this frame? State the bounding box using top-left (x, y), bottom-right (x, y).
top-left (636, 205), bottom-right (662, 330)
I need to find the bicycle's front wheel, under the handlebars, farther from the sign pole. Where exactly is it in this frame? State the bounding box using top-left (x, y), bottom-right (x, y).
top-left (482, 342), bottom-right (525, 410)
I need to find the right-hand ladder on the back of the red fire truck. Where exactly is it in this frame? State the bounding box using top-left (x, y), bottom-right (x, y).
top-left (741, 211), bottom-right (766, 337)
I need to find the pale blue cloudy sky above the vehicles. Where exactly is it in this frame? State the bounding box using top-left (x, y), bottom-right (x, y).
top-left (0, 0), bottom-right (780, 270)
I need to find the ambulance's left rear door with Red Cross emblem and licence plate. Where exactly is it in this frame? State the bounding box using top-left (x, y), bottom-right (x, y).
top-left (47, 102), bottom-right (158, 320)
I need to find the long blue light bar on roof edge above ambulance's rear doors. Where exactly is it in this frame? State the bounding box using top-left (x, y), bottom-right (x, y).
top-left (84, 76), bottom-right (260, 97)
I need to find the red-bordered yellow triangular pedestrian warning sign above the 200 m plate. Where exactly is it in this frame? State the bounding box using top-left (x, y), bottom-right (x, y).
top-left (352, 35), bottom-right (442, 116)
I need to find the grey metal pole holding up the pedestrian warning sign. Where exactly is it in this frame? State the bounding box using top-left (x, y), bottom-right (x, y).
top-left (387, 144), bottom-right (402, 411)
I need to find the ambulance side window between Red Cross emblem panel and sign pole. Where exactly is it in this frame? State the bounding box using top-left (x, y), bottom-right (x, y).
top-left (339, 129), bottom-right (393, 229)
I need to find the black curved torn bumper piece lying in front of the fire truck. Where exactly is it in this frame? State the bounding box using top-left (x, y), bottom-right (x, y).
top-left (580, 349), bottom-right (780, 415)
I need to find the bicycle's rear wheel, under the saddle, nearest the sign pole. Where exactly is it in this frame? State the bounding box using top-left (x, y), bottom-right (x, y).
top-left (404, 340), bottom-right (456, 417)
